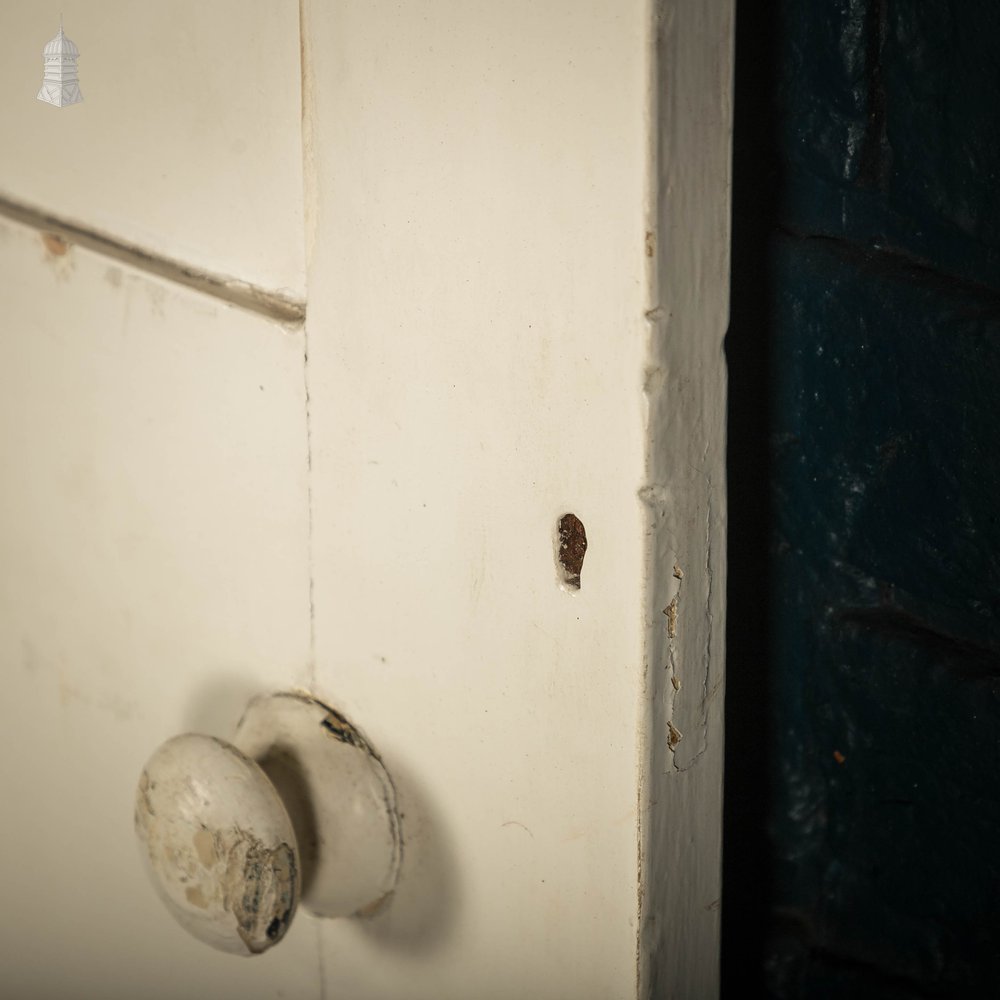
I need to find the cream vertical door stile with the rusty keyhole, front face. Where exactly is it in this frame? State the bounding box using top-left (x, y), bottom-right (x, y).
top-left (306, 0), bottom-right (649, 1000)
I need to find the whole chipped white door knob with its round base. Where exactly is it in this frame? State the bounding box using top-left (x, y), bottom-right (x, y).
top-left (135, 693), bottom-right (401, 955)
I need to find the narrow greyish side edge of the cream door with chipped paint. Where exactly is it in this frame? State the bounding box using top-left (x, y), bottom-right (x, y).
top-left (639, 3), bottom-right (734, 997)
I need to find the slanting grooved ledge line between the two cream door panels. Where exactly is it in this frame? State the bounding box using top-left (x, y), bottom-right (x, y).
top-left (0, 196), bottom-right (306, 324)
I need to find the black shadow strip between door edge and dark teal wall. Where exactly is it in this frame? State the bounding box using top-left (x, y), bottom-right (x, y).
top-left (722, 4), bottom-right (781, 1000)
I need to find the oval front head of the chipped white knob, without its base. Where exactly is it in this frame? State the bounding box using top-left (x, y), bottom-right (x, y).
top-left (135, 734), bottom-right (301, 955)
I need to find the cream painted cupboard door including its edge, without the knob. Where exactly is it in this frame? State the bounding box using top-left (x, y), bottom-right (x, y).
top-left (0, 0), bottom-right (732, 1000)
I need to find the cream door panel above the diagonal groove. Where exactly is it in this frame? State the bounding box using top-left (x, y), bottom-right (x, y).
top-left (0, 0), bottom-right (305, 296)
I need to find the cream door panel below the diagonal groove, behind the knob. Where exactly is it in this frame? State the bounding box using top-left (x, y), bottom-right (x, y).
top-left (0, 222), bottom-right (315, 1000)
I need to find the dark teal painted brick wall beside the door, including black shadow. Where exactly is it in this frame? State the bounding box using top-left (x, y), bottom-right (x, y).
top-left (723, 0), bottom-right (1000, 1000)
